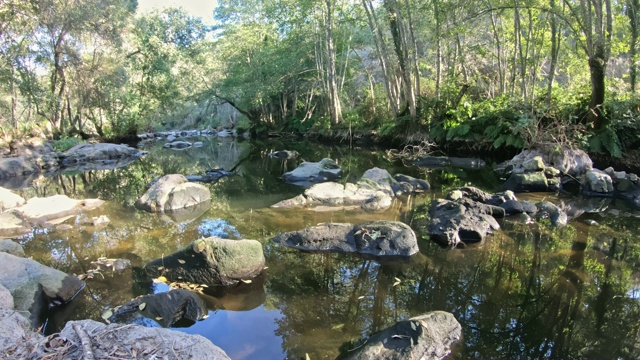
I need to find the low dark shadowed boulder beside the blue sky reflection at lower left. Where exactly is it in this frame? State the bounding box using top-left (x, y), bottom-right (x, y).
top-left (106, 289), bottom-right (207, 328)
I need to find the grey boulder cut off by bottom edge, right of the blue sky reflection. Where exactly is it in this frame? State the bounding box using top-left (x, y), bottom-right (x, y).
top-left (339, 311), bottom-right (462, 360)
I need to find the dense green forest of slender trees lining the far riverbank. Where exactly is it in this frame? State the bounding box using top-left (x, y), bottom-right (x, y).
top-left (0, 0), bottom-right (640, 156)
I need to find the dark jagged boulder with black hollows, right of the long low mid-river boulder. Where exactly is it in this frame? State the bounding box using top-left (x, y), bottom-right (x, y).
top-left (427, 199), bottom-right (500, 247)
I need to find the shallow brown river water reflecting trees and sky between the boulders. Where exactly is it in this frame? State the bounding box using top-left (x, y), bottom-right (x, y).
top-left (7, 136), bottom-right (640, 359)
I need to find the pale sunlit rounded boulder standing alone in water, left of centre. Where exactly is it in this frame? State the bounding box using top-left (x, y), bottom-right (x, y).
top-left (135, 174), bottom-right (211, 212)
